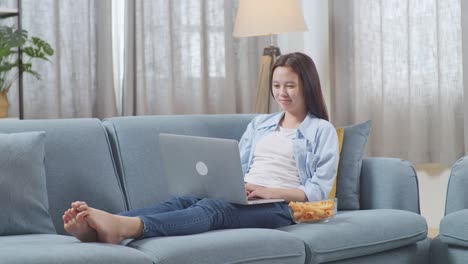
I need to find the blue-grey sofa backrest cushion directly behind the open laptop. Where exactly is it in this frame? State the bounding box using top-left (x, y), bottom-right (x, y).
top-left (104, 114), bottom-right (255, 209)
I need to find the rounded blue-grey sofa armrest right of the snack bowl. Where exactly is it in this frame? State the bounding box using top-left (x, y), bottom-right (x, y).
top-left (360, 158), bottom-right (420, 213)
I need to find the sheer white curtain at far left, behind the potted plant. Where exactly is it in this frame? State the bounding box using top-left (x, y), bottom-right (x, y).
top-left (0, 0), bottom-right (117, 119)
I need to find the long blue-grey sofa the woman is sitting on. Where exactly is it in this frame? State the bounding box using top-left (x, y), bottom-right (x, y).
top-left (0, 115), bottom-right (430, 264)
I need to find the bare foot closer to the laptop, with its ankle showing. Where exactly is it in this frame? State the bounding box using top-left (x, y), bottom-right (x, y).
top-left (77, 205), bottom-right (143, 244)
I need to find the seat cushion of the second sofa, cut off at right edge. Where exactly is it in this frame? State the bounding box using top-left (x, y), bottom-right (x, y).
top-left (439, 209), bottom-right (468, 247)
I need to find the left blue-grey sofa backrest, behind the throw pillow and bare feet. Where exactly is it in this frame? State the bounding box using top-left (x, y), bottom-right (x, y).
top-left (0, 118), bottom-right (126, 234)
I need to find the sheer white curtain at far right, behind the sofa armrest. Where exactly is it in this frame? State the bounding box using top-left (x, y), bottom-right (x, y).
top-left (331, 0), bottom-right (464, 164)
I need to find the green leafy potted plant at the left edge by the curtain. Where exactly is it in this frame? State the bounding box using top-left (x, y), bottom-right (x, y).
top-left (0, 25), bottom-right (54, 118)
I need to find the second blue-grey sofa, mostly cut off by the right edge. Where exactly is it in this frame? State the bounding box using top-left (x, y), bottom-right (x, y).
top-left (431, 156), bottom-right (468, 264)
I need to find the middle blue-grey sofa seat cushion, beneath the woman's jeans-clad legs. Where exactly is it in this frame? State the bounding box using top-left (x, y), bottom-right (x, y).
top-left (129, 228), bottom-right (306, 264)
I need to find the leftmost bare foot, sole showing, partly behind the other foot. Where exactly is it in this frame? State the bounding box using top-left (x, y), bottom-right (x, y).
top-left (62, 205), bottom-right (97, 242)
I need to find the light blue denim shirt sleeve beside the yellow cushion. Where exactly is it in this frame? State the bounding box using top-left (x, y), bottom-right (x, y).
top-left (298, 122), bottom-right (339, 201)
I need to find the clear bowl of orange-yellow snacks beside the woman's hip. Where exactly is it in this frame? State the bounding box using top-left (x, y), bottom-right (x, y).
top-left (289, 198), bottom-right (338, 223)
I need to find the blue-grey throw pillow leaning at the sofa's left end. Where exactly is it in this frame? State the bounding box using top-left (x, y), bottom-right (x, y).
top-left (0, 132), bottom-right (55, 236)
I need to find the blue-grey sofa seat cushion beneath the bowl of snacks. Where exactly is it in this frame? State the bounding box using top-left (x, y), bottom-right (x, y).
top-left (280, 209), bottom-right (427, 263)
